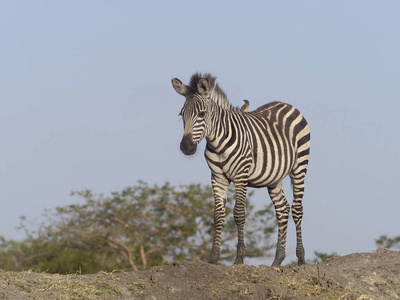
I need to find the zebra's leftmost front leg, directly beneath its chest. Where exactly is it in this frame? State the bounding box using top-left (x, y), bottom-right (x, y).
top-left (209, 175), bottom-right (229, 264)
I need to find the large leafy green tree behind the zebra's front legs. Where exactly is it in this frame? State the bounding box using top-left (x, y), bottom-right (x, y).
top-left (0, 182), bottom-right (275, 273)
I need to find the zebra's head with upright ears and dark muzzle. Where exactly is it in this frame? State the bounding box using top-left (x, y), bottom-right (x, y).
top-left (172, 76), bottom-right (211, 155)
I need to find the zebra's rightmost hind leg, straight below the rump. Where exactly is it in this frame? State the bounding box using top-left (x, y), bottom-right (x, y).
top-left (290, 170), bottom-right (306, 265)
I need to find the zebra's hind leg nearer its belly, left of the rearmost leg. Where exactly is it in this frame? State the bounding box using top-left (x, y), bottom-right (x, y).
top-left (268, 182), bottom-right (290, 267)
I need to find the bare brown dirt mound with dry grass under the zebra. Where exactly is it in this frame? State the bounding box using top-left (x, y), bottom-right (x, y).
top-left (0, 249), bottom-right (400, 300)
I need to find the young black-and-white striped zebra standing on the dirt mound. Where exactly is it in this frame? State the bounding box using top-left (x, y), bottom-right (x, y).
top-left (172, 73), bottom-right (310, 266)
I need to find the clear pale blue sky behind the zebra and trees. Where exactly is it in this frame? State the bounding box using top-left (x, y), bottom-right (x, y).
top-left (0, 1), bottom-right (400, 264)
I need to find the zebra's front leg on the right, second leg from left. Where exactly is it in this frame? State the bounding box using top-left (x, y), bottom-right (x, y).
top-left (233, 183), bottom-right (247, 264)
